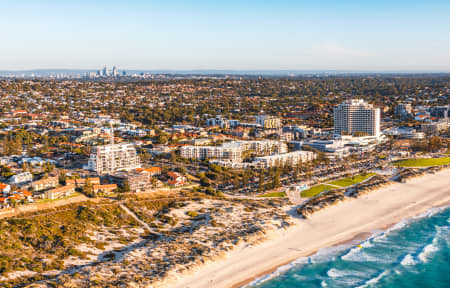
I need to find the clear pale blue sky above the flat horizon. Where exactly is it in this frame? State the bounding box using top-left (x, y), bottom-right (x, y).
top-left (0, 0), bottom-right (450, 71)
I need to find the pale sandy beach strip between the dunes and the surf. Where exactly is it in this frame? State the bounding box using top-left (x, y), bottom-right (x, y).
top-left (168, 169), bottom-right (450, 288)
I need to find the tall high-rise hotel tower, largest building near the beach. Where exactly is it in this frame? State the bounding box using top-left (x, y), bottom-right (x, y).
top-left (334, 99), bottom-right (380, 137)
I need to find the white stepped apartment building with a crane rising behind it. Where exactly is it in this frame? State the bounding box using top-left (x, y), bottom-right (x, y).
top-left (86, 143), bottom-right (141, 174)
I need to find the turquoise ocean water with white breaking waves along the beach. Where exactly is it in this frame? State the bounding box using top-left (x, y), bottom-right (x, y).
top-left (249, 207), bottom-right (450, 288)
